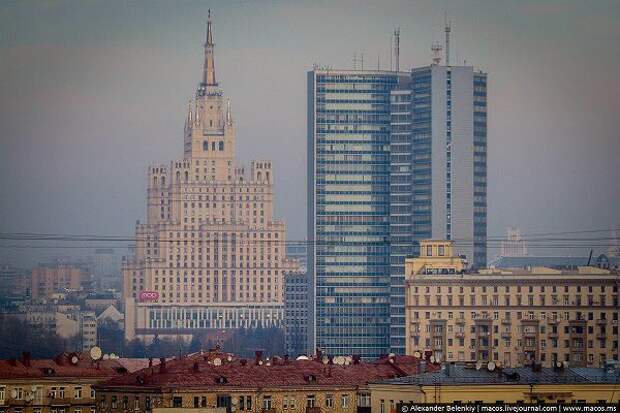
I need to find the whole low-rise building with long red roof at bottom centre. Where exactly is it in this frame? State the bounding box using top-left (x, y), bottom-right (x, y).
top-left (95, 351), bottom-right (436, 413)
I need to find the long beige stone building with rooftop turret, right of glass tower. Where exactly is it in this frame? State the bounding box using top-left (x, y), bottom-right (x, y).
top-left (405, 241), bottom-right (620, 367)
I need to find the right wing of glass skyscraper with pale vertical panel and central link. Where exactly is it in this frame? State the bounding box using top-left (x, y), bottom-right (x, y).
top-left (390, 65), bottom-right (487, 353)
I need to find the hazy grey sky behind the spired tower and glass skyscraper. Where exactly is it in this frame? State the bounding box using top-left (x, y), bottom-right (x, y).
top-left (0, 0), bottom-right (620, 262)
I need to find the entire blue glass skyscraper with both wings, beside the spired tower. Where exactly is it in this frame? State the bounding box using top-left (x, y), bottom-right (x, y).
top-left (308, 65), bottom-right (487, 357)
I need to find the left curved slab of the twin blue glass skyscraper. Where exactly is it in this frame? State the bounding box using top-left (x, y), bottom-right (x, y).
top-left (308, 69), bottom-right (404, 358)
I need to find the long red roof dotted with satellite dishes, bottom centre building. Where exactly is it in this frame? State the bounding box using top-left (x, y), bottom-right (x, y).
top-left (97, 352), bottom-right (436, 389)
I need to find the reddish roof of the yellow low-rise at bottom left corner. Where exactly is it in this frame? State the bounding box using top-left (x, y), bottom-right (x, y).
top-left (0, 353), bottom-right (148, 379)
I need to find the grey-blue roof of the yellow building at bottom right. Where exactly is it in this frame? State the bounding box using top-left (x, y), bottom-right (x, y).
top-left (376, 365), bottom-right (620, 385)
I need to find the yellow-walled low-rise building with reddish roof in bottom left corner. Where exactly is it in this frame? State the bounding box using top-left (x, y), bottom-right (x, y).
top-left (0, 352), bottom-right (146, 413)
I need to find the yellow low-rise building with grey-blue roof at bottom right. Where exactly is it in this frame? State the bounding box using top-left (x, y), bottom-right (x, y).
top-left (369, 364), bottom-right (620, 404)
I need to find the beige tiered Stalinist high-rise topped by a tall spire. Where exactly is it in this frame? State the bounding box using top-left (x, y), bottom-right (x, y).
top-left (123, 13), bottom-right (298, 341)
